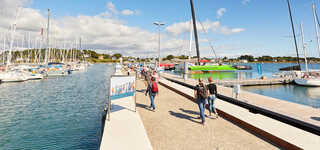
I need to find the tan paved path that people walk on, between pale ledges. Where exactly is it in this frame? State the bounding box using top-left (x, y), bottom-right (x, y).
top-left (137, 80), bottom-right (278, 150)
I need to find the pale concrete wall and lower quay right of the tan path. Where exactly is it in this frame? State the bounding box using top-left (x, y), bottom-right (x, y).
top-left (161, 74), bottom-right (320, 149)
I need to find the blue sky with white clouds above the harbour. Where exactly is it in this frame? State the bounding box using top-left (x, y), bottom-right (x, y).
top-left (0, 0), bottom-right (320, 57)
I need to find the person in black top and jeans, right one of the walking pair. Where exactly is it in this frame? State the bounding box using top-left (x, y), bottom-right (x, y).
top-left (207, 77), bottom-right (219, 118)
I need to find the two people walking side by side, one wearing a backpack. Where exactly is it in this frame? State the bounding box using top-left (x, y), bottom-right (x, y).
top-left (194, 77), bottom-right (218, 125)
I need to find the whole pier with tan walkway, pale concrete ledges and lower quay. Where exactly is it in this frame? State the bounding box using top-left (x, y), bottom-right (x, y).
top-left (100, 70), bottom-right (320, 150)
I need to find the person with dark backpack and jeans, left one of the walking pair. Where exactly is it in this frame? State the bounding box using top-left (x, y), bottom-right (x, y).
top-left (194, 79), bottom-right (208, 125)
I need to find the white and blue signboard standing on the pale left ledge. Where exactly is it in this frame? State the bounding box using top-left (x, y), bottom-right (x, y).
top-left (110, 76), bottom-right (136, 100)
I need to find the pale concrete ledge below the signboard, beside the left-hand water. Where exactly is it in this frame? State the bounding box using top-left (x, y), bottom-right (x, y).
top-left (100, 97), bottom-right (152, 150)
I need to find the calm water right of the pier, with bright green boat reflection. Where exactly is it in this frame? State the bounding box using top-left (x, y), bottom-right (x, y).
top-left (171, 63), bottom-right (320, 108)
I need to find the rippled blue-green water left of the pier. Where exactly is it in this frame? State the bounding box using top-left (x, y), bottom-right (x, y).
top-left (0, 64), bottom-right (113, 150)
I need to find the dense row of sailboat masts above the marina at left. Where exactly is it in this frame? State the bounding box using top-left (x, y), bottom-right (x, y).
top-left (0, 8), bottom-right (84, 68)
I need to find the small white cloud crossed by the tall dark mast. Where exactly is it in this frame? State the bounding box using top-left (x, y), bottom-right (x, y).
top-left (166, 20), bottom-right (245, 36)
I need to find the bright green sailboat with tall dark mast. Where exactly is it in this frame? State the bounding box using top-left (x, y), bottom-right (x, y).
top-left (189, 0), bottom-right (236, 73)
